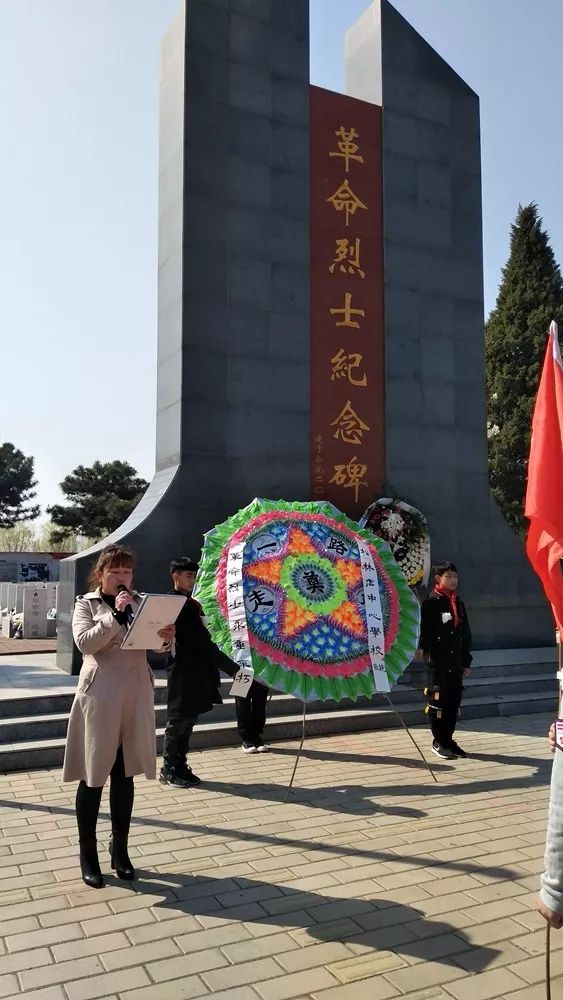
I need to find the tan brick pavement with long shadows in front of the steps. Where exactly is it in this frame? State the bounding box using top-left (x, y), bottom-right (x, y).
top-left (0, 716), bottom-right (563, 1000)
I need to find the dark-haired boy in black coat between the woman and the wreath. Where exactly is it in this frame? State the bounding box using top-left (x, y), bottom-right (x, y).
top-left (160, 556), bottom-right (237, 788)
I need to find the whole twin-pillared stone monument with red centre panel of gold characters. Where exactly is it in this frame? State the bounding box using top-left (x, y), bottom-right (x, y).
top-left (58, 0), bottom-right (552, 670)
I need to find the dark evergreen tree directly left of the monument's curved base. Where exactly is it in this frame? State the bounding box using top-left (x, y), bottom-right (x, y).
top-left (47, 461), bottom-right (148, 544)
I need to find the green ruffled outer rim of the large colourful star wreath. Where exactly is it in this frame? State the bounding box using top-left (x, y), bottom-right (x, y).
top-left (194, 499), bottom-right (420, 702)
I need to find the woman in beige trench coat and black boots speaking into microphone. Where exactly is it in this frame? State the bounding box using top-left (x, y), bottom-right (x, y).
top-left (63, 545), bottom-right (174, 889)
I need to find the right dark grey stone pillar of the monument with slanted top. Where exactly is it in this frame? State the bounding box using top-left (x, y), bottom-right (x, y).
top-left (347, 0), bottom-right (553, 647)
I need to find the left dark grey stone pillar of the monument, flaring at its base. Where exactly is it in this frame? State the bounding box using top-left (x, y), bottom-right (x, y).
top-left (57, 0), bottom-right (309, 671)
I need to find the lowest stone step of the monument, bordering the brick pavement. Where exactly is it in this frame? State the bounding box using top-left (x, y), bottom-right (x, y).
top-left (0, 690), bottom-right (555, 773)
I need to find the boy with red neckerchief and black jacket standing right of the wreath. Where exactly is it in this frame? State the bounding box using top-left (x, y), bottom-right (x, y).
top-left (420, 562), bottom-right (472, 760)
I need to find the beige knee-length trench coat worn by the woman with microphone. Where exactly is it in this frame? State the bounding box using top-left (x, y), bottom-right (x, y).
top-left (63, 589), bottom-right (156, 788)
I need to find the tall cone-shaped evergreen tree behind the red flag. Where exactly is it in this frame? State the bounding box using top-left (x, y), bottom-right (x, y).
top-left (485, 204), bottom-right (563, 536)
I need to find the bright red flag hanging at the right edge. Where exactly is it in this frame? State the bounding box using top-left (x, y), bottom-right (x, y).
top-left (525, 323), bottom-right (563, 642)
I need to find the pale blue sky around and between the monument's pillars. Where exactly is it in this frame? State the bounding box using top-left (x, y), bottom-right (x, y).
top-left (0, 0), bottom-right (563, 504)
